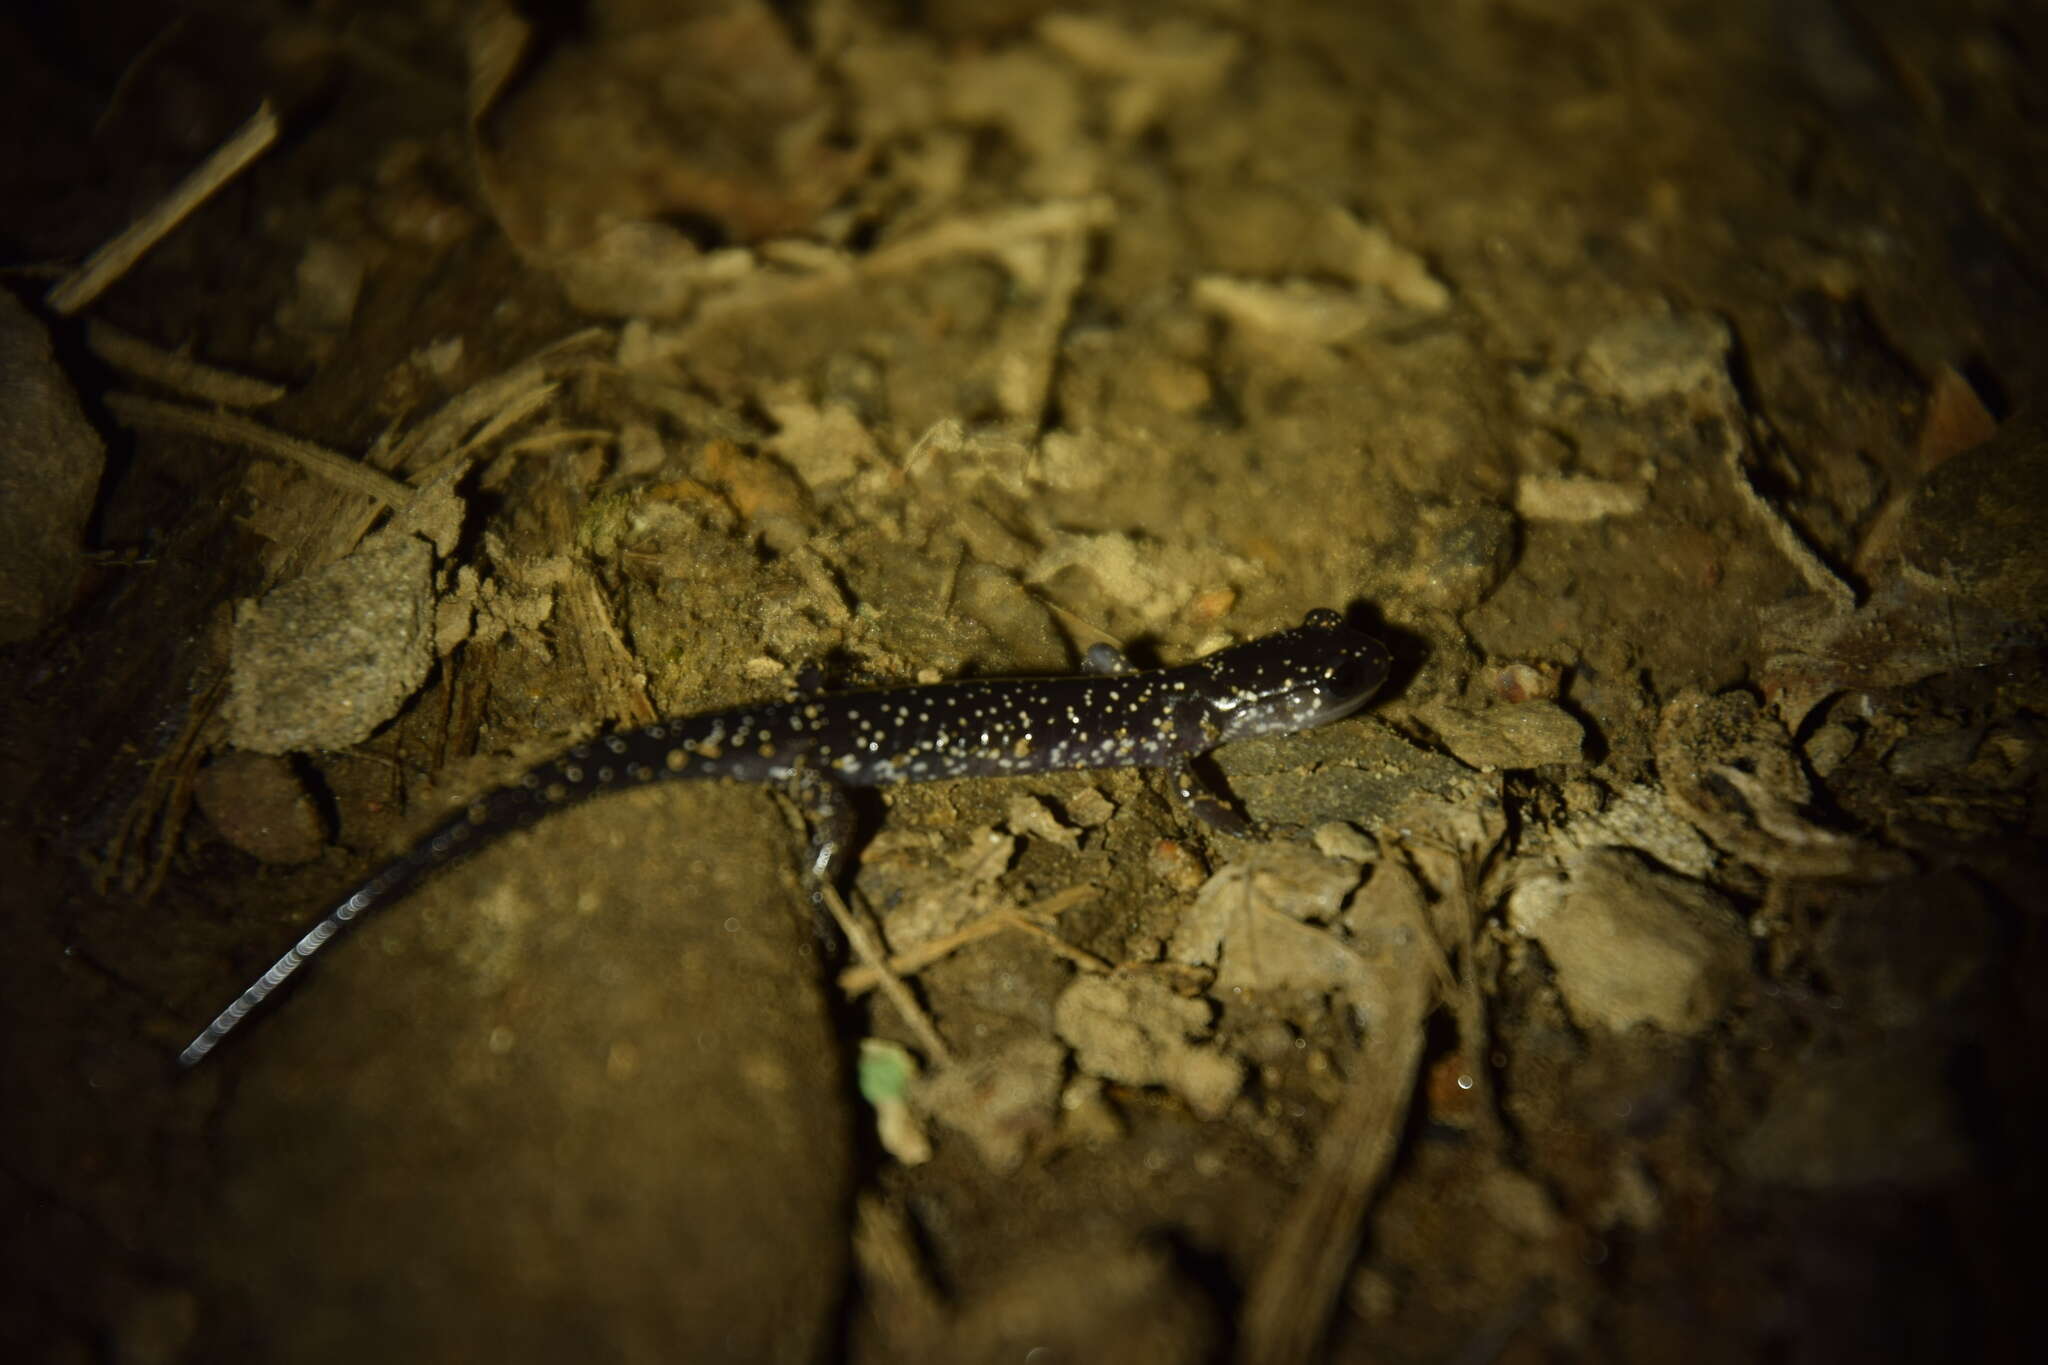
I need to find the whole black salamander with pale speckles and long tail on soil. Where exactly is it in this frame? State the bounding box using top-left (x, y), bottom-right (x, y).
top-left (178, 610), bottom-right (1389, 1066)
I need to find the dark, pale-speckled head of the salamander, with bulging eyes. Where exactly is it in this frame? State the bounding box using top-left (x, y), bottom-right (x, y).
top-left (1196, 610), bottom-right (1391, 743)
